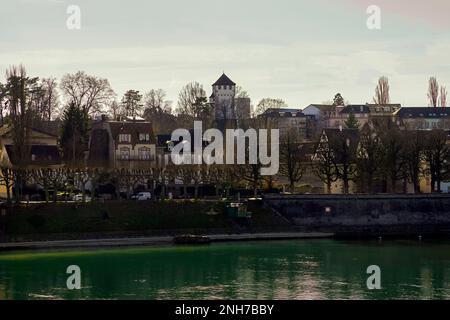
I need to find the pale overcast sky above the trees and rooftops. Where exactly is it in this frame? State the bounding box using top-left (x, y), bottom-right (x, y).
top-left (0, 0), bottom-right (450, 108)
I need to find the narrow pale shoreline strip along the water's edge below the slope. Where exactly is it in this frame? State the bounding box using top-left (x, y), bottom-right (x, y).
top-left (0, 232), bottom-right (333, 252)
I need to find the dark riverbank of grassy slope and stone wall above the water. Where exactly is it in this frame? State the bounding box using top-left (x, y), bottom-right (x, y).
top-left (0, 195), bottom-right (450, 250)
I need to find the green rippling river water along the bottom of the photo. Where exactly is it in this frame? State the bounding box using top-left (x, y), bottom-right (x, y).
top-left (0, 240), bottom-right (450, 299)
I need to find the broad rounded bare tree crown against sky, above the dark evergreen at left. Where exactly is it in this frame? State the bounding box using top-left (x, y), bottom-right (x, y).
top-left (60, 71), bottom-right (116, 116)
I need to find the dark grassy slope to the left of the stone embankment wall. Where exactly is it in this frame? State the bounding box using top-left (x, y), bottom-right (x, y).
top-left (0, 201), bottom-right (292, 240)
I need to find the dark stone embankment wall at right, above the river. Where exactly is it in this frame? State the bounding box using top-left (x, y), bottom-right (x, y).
top-left (264, 194), bottom-right (450, 235)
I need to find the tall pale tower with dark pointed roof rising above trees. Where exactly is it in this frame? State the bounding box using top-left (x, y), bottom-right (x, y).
top-left (209, 73), bottom-right (236, 120)
